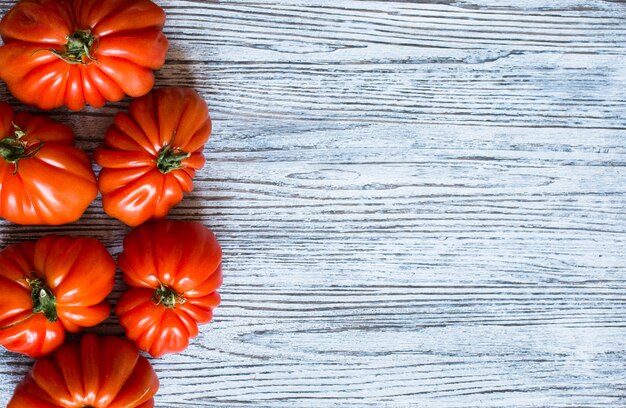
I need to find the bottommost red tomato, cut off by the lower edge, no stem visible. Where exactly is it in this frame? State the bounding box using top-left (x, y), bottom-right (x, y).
top-left (8, 334), bottom-right (159, 408)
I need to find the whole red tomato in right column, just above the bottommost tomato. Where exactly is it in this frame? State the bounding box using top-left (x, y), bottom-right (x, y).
top-left (115, 220), bottom-right (222, 357)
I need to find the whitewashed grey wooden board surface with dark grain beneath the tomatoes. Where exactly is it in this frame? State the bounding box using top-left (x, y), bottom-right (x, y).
top-left (0, 0), bottom-right (626, 407)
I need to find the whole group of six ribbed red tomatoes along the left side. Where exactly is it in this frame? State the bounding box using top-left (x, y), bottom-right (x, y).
top-left (0, 0), bottom-right (222, 408)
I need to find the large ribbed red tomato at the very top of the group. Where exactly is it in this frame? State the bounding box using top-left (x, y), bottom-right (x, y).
top-left (0, 0), bottom-right (168, 110)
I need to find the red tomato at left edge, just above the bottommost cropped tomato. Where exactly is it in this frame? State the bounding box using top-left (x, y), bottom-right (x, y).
top-left (0, 235), bottom-right (115, 357)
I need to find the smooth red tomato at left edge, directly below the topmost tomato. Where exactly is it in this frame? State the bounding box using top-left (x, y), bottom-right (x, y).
top-left (0, 103), bottom-right (98, 225)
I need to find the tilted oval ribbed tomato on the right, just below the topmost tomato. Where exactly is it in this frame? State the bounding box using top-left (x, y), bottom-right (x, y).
top-left (94, 88), bottom-right (211, 226)
